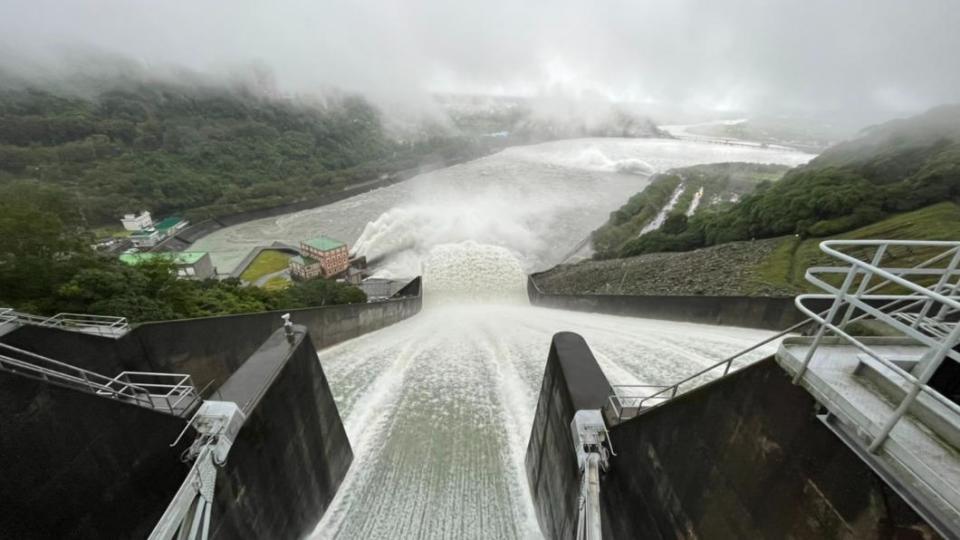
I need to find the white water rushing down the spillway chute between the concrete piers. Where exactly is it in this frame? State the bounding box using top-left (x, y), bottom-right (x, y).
top-left (314, 256), bottom-right (773, 539)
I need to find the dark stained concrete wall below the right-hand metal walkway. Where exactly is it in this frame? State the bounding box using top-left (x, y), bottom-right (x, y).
top-left (600, 358), bottom-right (937, 539)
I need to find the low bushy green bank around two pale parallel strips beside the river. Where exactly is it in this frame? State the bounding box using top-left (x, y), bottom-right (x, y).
top-left (592, 163), bottom-right (788, 258)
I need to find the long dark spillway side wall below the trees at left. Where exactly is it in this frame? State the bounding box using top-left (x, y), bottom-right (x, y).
top-left (0, 284), bottom-right (421, 388)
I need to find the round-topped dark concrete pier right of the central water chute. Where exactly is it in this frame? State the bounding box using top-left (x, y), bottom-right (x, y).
top-left (526, 332), bottom-right (613, 539)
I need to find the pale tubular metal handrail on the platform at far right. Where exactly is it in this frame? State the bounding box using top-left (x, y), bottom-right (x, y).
top-left (794, 240), bottom-right (960, 452)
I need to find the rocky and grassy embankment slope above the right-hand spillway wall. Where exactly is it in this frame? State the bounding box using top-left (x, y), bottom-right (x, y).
top-left (535, 202), bottom-right (960, 296)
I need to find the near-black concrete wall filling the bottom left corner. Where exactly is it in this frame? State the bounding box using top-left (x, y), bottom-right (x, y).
top-left (0, 372), bottom-right (192, 539)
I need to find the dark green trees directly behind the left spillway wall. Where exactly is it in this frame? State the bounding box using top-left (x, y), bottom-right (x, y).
top-left (0, 181), bottom-right (366, 321)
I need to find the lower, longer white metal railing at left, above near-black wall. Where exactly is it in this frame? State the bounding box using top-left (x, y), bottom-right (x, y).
top-left (0, 343), bottom-right (200, 416)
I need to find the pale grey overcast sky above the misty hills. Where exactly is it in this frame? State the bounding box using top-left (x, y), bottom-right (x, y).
top-left (0, 0), bottom-right (960, 120)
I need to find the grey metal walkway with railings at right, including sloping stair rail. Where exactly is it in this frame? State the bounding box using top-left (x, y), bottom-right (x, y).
top-left (604, 240), bottom-right (960, 538)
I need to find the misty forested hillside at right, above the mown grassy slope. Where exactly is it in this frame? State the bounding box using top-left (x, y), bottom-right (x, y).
top-left (600, 105), bottom-right (960, 256)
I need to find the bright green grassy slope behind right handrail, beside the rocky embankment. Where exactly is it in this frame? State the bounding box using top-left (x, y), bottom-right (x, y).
top-left (755, 202), bottom-right (960, 293)
